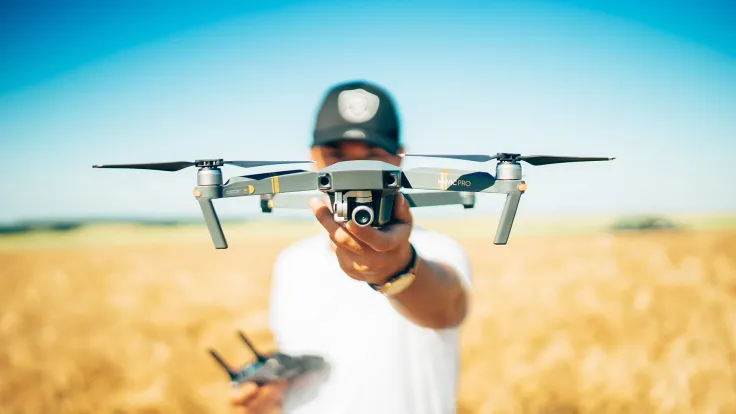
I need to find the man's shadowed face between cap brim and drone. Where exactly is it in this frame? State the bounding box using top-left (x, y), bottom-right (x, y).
top-left (310, 141), bottom-right (403, 169)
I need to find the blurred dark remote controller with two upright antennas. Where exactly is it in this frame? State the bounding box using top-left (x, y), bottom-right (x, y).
top-left (209, 331), bottom-right (325, 387)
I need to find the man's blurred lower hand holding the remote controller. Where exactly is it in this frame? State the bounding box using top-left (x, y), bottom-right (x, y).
top-left (230, 381), bottom-right (286, 414)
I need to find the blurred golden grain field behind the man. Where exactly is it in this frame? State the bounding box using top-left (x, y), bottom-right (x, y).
top-left (0, 215), bottom-right (736, 414)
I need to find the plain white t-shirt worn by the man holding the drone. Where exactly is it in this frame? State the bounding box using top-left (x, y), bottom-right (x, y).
top-left (270, 226), bottom-right (471, 414)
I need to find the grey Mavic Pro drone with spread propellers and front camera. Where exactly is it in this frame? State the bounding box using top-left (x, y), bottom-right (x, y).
top-left (93, 153), bottom-right (615, 249)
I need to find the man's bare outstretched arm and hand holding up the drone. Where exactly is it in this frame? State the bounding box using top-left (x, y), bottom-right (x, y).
top-left (312, 193), bottom-right (468, 329)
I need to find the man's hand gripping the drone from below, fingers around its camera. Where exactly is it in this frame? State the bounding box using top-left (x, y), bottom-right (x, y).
top-left (310, 193), bottom-right (413, 284)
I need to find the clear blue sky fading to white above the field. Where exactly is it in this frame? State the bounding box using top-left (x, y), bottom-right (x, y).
top-left (0, 1), bottom-right (736, 222)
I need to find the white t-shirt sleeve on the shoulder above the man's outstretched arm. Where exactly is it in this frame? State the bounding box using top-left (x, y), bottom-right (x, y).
top-left (411, 230), bottom-right (472, 290)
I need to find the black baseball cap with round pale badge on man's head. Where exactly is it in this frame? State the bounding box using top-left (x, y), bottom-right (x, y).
top-left (312, 81), bottom-right (401, 154)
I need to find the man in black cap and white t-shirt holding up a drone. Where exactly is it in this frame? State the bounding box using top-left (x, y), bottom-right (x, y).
top-left (231, 82), bottom-right (471, 414)
